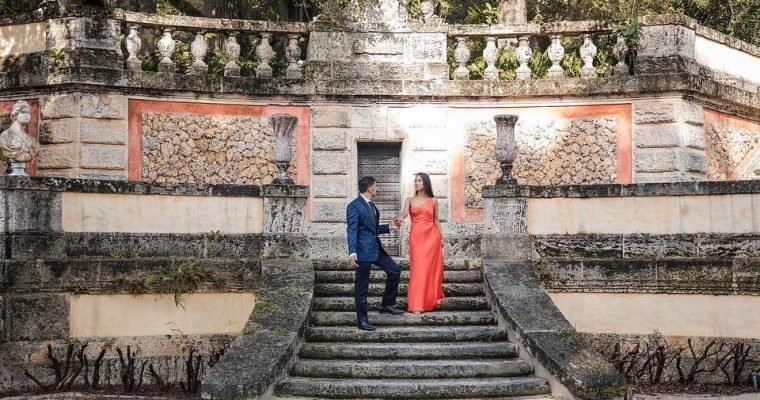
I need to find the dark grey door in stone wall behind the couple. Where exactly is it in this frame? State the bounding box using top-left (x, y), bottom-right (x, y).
top-left (357, 143), bottom-right (401, 256)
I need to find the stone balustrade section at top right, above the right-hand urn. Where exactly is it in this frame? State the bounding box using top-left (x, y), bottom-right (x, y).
top-left (448, 21), bottom-right (629, 80)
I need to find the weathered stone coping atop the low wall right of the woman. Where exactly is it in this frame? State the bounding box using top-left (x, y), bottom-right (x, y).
top-left (483, 180), bottom-right (760, 198)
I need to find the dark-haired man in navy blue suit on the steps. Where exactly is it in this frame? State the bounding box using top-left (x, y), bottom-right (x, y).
top-left (346, 176), bottom-right (404, 331)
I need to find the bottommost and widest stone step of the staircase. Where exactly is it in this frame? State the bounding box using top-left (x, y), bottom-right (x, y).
top-left (276, 377), bottom-right (551, 399)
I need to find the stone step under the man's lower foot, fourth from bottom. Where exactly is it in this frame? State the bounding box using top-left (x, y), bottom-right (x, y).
top-left (306, 326), bottom-right (507, 343)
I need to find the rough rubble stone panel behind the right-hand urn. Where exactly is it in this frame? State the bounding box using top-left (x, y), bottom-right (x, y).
top-left (464, 117), bottom-right (618, 208)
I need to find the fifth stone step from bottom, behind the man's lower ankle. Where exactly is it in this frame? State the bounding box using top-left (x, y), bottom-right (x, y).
top-left (310, 311), bottom-right (496, 326)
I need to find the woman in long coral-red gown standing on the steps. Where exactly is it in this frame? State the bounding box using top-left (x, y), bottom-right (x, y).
top-left (399, 173), bottom-right (444, 313)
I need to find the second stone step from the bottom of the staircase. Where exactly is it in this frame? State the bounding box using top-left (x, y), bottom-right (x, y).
top-left (290, 359), bottom-right (533, 379)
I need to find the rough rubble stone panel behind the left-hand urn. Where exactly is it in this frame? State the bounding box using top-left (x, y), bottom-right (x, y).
top-left (142, 113), bottom-right (297, 185)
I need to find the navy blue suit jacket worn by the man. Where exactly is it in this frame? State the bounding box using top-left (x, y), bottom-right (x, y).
top-left (346, 196), bottom-right (391, 262)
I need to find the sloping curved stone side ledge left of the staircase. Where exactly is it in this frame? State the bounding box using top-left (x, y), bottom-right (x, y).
top-left (201, 260), bottom-right (314, 400)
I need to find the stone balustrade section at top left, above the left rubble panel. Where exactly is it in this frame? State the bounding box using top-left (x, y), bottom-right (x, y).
top-left (123, 12), bottom-right (308, 79)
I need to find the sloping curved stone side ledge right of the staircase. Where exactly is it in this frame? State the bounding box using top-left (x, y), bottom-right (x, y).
top-left (483, 260), bottom-right (624, 399)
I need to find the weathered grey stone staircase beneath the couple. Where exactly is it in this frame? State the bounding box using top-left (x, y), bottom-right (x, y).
top-left (275, 260), bottom-right (550, 400)
